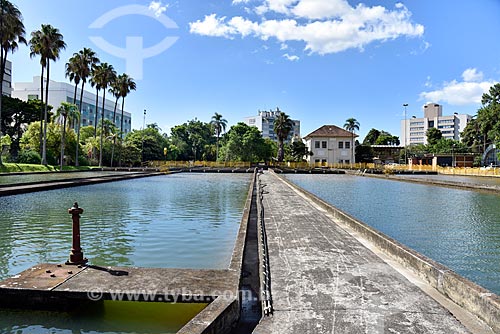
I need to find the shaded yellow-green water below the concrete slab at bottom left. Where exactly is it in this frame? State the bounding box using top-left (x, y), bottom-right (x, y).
top-left (0, 301), bottom-right (207, 334)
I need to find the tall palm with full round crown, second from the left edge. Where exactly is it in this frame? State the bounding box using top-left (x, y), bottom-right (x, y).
top-left (30, 24), bottom-right (66, 165)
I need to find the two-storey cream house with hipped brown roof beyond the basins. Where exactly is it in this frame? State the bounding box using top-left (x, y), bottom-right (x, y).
top-left (304, 125), bottom-right (358, 165)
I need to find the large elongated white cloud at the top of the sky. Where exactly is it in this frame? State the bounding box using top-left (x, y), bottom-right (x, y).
top-left (190, 0), bottom-right (424, 54)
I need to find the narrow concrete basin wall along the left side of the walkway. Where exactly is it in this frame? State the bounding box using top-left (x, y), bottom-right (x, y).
top-left (177, 170), bottom-right (257, 334)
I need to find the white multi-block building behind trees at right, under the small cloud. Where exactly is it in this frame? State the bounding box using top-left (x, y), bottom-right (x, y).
top-left (401, 103), bottom-right (472, 146)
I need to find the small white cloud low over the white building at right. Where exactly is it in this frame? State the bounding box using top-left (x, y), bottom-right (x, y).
top-left (420, 68), bottom-right (495, 106)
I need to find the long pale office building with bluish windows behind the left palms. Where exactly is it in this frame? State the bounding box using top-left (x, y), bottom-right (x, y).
top-left (12, 76), bottom-right (132, 135)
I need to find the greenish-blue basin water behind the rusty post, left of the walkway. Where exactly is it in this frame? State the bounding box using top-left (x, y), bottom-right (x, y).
top-left (0, 174), bottom-right (250, 279)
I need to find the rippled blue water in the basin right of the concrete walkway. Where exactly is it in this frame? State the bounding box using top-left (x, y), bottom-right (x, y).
top-left (286, 175), bottom-right (500, 294)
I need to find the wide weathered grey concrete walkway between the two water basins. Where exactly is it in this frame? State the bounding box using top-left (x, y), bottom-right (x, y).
top-left (254, 172), bottom-right (469, 334)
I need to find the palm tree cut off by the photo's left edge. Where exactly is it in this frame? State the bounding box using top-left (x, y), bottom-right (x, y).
top-left (0, 0), bottom-right (26, 165)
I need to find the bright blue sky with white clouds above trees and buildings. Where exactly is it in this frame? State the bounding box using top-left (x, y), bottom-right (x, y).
top-left (9, 0), bottom-right (500, 139)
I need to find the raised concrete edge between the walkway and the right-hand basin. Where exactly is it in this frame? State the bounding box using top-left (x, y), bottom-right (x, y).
top-left (274, 173), bottom-right (500, 333)
